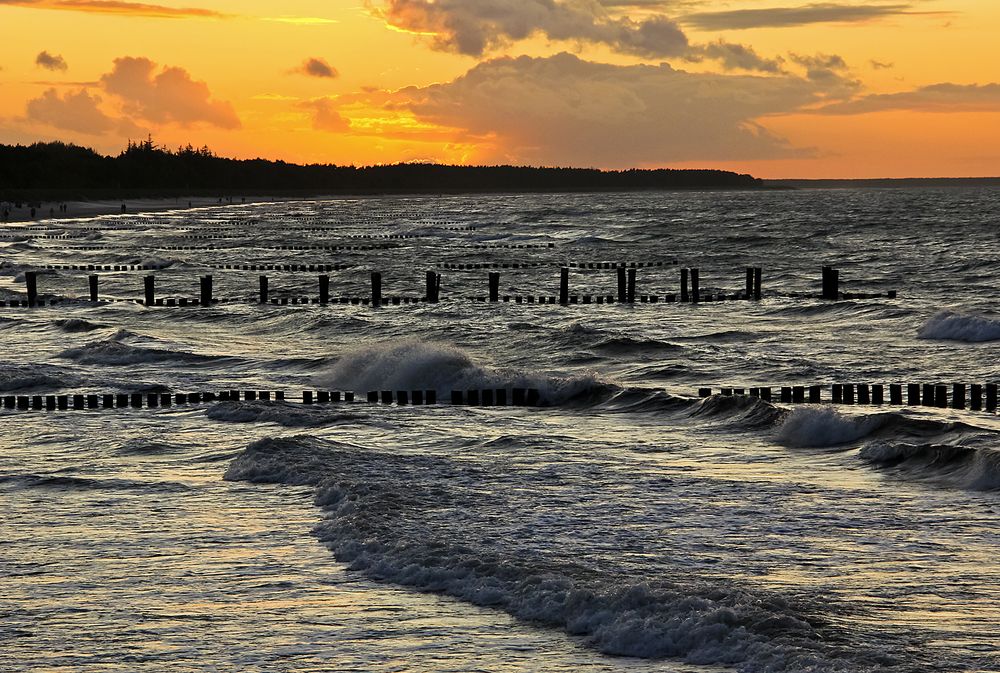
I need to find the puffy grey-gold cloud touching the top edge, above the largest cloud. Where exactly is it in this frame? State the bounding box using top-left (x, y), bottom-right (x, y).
top-left (375, 0), bottom-right (688, 58)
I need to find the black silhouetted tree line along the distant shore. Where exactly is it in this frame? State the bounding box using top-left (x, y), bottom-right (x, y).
top-left (0, 138), bottom-right (762, 199)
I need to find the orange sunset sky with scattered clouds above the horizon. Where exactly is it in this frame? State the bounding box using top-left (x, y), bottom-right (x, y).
top-left (0, 0), bottom-right (1000, 178)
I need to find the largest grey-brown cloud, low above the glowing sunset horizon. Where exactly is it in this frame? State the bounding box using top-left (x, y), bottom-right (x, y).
top-left (364, 53), bottom-right (823, 167)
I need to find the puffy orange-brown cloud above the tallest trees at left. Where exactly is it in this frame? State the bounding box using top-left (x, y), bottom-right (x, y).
top-left (101, 57), bottom-right (240, 129)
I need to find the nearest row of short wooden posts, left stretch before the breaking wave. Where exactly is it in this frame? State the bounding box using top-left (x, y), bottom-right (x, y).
top-left (2, 388), bottom-right (541, 411)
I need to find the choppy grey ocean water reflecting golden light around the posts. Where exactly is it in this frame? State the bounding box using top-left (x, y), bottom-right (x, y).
top-left (0, 189), bottom-right (1000, 673)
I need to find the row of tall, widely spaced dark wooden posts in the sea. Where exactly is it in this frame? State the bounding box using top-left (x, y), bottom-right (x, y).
top-left (13, 266), bottom-right (896, 307)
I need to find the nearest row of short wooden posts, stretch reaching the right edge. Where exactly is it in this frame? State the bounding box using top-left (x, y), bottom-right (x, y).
top-left (698, 383), bottom-right (997, 411)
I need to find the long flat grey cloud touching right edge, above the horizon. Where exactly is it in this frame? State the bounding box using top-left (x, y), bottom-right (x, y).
top-left (813, 82), bottom-right (1000, 115)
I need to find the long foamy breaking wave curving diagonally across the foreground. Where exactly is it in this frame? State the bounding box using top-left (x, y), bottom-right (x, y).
top-left (225, 436), bottom-right (893, 672)
